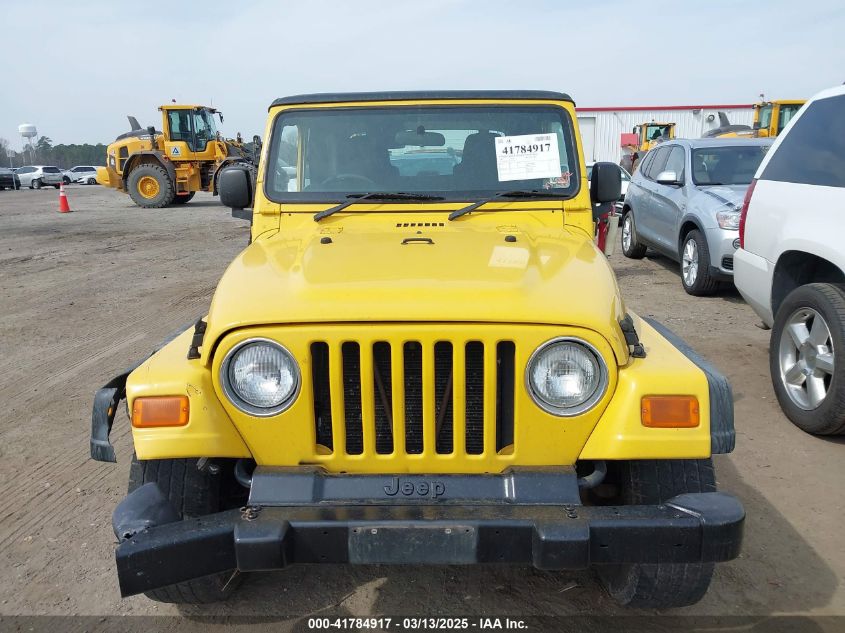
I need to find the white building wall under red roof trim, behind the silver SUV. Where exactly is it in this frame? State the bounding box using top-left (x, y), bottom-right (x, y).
top-left (578, 106), bottom-right (754, 163)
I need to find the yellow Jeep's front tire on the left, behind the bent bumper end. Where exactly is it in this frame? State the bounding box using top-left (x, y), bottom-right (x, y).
top-left (129, 456), bottom-right (241, 604)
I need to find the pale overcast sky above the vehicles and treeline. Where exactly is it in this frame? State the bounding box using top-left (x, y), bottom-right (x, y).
top-left (0, 0), bottom-right (845, 148)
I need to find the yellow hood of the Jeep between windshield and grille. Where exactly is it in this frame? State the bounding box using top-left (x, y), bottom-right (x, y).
top-left (204, 217), bottom-right (627, 359)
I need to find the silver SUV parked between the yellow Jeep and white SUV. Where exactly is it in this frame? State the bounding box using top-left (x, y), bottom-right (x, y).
top-left (622, 138), bottom-right (774, 296)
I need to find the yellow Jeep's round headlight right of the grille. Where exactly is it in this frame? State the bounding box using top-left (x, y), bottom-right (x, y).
top-left (526, 339), bottom-right (607, 416)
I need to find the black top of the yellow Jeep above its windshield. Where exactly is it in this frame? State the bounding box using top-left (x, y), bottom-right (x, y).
top-left (270, 90), bottom-right (575, 108)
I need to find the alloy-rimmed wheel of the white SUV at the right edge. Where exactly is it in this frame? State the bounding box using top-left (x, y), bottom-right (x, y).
top-left (769, 284), bottom-right (845, 435)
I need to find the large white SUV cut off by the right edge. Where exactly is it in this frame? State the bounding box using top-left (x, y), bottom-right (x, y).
top-left (734, 87), bottom-right (845, 435)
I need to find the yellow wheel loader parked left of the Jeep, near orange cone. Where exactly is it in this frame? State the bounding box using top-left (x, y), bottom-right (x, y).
top-left (97, 104), bottom-right (260, 208)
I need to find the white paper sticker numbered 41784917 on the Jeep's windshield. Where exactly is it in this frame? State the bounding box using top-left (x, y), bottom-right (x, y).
top-left (496, 134), bottom-right (561, 182)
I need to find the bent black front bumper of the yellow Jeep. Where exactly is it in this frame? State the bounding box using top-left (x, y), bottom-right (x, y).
top-left (109, 468), bottom-right (745, 596)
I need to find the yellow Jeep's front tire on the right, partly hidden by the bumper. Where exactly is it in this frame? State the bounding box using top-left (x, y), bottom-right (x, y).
top-left (597, 459), bottom-right (716, 609)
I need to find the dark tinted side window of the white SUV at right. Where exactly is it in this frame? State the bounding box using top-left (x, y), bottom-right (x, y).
top-left (760, 95), bottom-right (845, 187)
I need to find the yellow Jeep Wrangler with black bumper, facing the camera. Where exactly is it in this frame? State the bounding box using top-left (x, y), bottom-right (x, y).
top-left (91, 91), bottom-right (744, 607)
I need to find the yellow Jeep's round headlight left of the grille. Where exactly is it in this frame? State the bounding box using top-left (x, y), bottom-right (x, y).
top-left (220, 339), bottom-right (299, 416)
